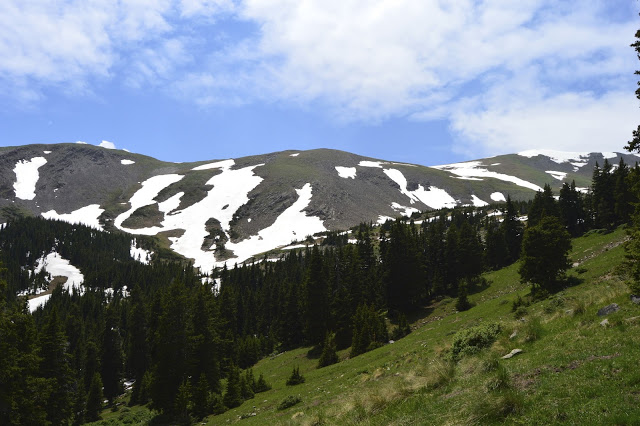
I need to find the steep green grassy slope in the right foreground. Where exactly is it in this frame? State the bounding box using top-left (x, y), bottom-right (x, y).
top-left (91, 229), bottom-right (640, 425)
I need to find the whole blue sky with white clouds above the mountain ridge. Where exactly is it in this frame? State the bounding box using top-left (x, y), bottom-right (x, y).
top-left (0, 0), bottom-right (640, 165)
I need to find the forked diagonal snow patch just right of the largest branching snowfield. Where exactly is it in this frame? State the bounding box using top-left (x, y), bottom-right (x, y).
top-left (226, 183), bottom-right (327, 263)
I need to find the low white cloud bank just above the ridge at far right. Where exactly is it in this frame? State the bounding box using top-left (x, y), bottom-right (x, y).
top-left (451, 91), bottom-right (638, 155)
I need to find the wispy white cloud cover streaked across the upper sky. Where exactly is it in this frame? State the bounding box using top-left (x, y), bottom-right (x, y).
top-left (0, 0), bottom-right (637, 154)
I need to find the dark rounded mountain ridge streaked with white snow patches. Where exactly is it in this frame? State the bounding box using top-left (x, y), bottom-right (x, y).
top-left (0, 144), bottom-right (638, 270)
